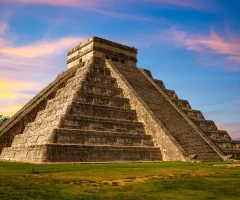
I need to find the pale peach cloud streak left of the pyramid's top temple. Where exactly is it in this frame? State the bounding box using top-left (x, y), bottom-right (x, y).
top-left (0, 18), bottom-right (86, 74)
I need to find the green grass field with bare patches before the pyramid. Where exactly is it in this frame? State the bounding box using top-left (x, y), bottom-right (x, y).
top-left (0, 162), bottom-right (240, 200)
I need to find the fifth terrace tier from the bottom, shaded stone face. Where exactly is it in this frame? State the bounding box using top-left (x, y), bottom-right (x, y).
top-left (75, 93), bottom-right (130, 109)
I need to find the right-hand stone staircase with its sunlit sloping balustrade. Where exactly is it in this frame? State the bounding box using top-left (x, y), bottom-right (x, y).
top-left (107, 61), bottom-right (223, 161)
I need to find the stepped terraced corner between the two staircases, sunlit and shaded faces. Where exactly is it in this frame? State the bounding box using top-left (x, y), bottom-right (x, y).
top-left (1, 58), bottom-right (161, 162)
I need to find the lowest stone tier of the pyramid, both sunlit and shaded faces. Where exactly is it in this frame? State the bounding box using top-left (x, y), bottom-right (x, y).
top-left (0, 144), bottom-right (162, 163)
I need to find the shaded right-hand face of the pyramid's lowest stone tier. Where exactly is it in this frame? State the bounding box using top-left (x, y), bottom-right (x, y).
top-left (45, 144), bottom-right (162, 162)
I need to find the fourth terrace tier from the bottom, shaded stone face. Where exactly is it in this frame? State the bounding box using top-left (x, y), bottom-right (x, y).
top-left (70, 103), bottom-right (137, 121)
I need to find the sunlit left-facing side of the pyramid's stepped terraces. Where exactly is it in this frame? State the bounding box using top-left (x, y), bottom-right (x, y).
top-left (0, 60), bottom-right (92, 162)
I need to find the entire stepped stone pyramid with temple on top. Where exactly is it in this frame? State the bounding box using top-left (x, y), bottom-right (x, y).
top-left (0, 37), bottom-right (240, 163)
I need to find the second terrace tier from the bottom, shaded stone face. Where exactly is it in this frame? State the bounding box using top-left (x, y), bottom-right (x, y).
top-left (53, 129), bottom-right (154, 146)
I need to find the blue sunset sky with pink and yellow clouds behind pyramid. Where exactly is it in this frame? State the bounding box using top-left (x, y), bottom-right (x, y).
top-left (0, 0), bottom-right (240, 140)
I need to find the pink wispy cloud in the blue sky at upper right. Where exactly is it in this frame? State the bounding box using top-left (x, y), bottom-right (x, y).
top-left (168, 27), bottom-right (240, 71)
